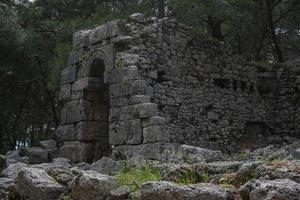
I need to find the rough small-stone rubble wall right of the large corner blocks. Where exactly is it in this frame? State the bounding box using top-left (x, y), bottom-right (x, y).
top-left (122, 18), bottom-right (271, 150)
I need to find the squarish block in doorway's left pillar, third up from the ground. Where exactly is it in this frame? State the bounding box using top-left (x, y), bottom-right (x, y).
top-left (66, 100), bottom-right (94, 124)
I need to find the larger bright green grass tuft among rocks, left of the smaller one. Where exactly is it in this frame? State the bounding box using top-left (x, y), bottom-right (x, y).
top-left (117, 166), bottom-right (162, 190)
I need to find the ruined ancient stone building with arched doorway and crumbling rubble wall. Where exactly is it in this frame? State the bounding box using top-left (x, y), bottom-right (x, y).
top-left (57, 14), bottom-right (300, 162)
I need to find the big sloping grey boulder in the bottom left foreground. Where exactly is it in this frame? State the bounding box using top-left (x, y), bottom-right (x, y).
top-left (16, 168), bottom-right (66, 200)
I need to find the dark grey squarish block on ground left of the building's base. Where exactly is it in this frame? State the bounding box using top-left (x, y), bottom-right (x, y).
top-left (22, 147), bottom-right (49, 164)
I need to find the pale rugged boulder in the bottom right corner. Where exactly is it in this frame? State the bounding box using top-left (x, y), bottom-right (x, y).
top-left (240, 179), bottom-right (300, 200)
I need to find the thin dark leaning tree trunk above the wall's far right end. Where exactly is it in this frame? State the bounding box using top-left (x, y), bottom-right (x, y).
top-left (265, 0), bottom-right (284, 62)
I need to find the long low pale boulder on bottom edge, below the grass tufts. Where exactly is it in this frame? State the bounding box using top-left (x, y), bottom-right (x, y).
top-left (141, 182), bottom-right (234, 200)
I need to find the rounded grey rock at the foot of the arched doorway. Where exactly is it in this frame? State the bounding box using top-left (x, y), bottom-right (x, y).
top-left (91, 157), bottom-right (124, 175)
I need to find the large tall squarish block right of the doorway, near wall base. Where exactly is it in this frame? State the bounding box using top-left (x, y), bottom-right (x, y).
top-left (109, 119), bottom-right (142, 145)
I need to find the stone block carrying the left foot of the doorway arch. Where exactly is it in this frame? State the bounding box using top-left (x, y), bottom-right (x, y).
top-left (72, 77), bottom-right (103, 93)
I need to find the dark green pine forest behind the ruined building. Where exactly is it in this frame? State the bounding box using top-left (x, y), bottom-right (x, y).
top-left (0, 0), bottom-right (300, 153)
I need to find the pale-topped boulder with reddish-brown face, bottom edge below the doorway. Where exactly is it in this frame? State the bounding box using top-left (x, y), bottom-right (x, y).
top-left (71, 171), bottom-right (119, 200)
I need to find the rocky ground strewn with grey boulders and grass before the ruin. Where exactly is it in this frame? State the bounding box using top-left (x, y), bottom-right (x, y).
top-left (0, 141), bottom-right (300, 200)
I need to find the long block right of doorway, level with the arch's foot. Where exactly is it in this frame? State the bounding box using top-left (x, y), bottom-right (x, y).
top-left (109, 80), bottom-right (147, 98)
